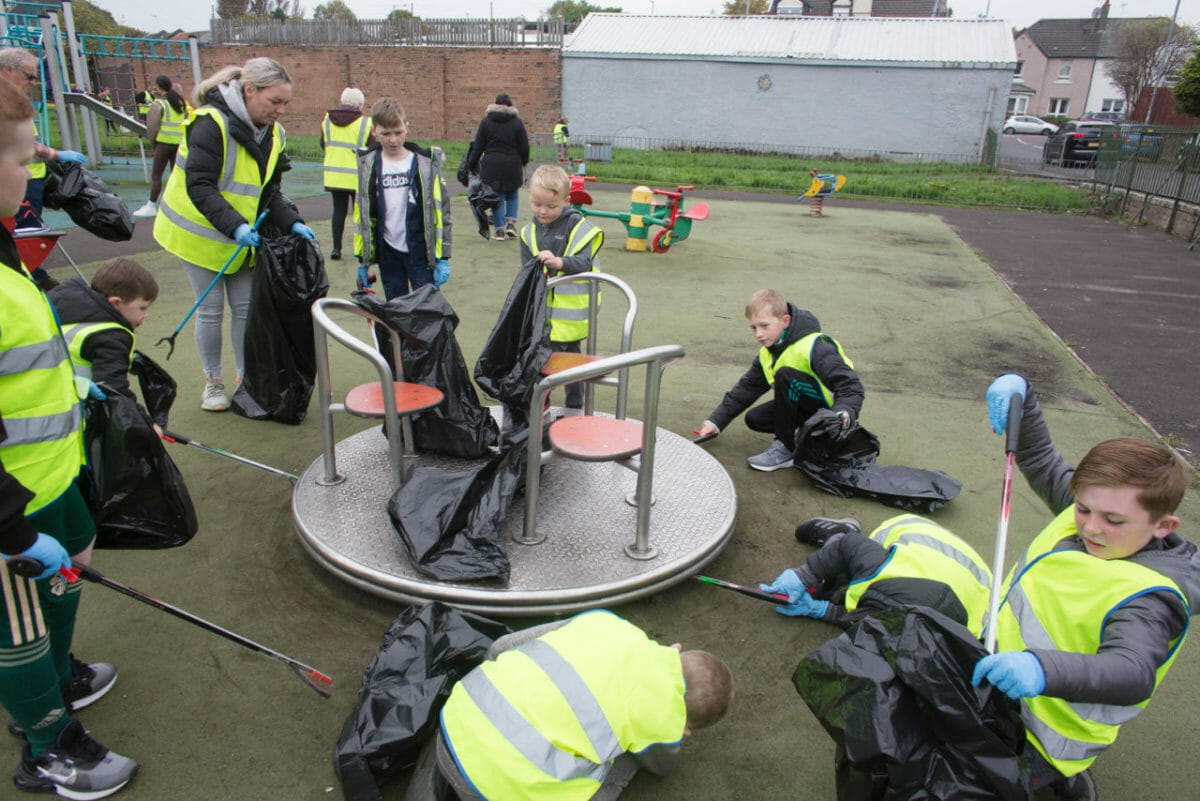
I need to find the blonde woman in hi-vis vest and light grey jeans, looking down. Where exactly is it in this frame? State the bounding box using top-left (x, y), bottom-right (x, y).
top-left (154, 58), bottom-right (316, 411)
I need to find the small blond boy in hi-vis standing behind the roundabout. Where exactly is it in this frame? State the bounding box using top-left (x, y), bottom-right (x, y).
top-left (521, 164), bottom-right (604, 415)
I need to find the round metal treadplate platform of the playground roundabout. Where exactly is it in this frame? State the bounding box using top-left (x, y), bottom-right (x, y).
top-left (292, 410), bottom-right (737, 615)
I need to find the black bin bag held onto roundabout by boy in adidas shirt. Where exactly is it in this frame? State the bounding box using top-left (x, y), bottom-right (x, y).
top-left (352, 284), bottom-right (499, 459)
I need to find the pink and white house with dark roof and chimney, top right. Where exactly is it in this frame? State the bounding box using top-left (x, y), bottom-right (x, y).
top-left (1008, 0), bottom-right (1152, 118)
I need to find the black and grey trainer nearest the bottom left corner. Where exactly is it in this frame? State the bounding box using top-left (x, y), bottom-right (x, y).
top-left (12, 721), bottom-right (138, 801)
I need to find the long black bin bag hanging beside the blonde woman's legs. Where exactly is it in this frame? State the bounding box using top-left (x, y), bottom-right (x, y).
top-left (230, 234), bottom-right (329, 426)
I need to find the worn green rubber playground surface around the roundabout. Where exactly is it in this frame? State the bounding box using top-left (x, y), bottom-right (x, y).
top-left (5, 181), bottom-right (1200, 801)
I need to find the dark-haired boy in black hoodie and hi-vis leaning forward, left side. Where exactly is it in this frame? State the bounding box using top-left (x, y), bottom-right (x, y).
top-left (49, 258), bottom-right (158, 398)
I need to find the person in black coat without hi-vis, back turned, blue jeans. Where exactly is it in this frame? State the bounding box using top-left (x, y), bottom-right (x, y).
top-left (467, 92), bottom-right (529, 241)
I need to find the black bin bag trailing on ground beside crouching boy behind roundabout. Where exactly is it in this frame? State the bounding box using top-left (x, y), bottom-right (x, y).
top-left (792, 409), bottom-right (962, 514)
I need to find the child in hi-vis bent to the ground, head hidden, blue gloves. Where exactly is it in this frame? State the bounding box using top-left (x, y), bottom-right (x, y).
top-left (760, 514), bottom-right (991, 637)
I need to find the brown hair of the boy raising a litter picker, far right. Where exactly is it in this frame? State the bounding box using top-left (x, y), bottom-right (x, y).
top-left (1070, 436), bottom-right (1192, 520)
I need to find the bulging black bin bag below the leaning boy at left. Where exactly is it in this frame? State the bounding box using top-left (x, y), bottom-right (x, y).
top-left (84, 391), bottom-right (197, 549)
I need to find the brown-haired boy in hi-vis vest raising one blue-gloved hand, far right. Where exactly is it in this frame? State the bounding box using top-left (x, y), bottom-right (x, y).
top-left (972, 373), bottom-right (1200, 800)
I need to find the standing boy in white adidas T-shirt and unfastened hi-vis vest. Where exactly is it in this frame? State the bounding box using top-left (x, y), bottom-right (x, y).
top-left (354, 97), bottom-right (450, 299)
